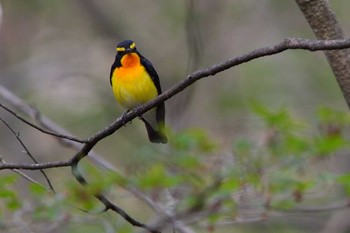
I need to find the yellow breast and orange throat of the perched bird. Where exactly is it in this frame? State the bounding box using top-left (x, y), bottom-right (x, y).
top-left (112, 53), bottom-right (158, 109)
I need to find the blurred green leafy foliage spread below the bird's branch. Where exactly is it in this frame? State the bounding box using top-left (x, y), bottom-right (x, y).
top-left (0, 106), bottom-right (350, 232)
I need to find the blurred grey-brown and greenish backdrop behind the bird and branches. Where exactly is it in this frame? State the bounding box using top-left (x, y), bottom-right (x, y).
top-left (0, 0), bottom-right (350, 232)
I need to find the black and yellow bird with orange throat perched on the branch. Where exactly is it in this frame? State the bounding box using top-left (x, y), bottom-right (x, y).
top-left (110, 40), bottom-right (168, 143)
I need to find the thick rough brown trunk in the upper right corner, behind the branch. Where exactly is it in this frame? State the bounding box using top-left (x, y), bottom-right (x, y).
top-left (295, 0), bottom-right (350, 108)
